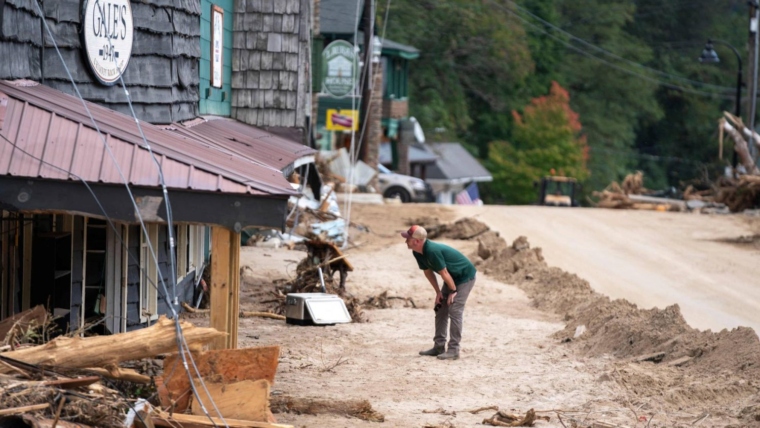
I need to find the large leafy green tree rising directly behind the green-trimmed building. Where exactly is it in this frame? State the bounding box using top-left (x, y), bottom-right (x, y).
top-left (378, 0), bottom-right (533, 140)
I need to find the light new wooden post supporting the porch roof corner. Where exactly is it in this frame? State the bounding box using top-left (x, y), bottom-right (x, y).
top-left (210, 226), bottom-right (240, 349)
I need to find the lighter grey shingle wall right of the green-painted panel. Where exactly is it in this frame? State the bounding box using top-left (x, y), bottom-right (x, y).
top-left (232, 0), bottom-right (310, 128)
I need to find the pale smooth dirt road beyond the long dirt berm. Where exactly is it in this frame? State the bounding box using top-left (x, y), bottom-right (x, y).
top-left (457, 206), bottom-right (760, 332)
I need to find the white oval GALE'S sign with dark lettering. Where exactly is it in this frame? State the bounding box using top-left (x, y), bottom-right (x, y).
top-left (82, 0), bottom-right (134, 85)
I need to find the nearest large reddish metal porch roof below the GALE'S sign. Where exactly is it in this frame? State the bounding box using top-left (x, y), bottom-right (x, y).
top-left (0, 80), bottom-right (297, 196)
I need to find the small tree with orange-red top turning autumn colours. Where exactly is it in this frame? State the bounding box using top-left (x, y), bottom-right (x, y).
top-left (484, 82), bottom-right (589, 204)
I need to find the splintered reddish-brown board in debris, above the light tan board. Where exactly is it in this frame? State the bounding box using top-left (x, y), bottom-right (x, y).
top-left (159, 346), bottom-right (280, 412)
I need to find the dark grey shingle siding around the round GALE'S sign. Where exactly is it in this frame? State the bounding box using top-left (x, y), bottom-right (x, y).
top-left (0, 0), bottom-right (201, 123)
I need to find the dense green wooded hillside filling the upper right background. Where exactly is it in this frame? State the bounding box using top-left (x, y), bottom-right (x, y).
top-left (379, 0), bottom-right (760, 203)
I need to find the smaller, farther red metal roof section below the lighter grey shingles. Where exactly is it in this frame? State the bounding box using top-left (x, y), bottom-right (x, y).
top-left (177, 118), bottom-right (317, 171)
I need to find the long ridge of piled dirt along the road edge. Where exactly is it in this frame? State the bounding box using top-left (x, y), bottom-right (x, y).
top-left (452, 220), bottom-right (760, 388)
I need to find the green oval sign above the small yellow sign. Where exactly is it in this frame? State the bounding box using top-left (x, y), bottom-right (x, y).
top-left (322, 40), bottom-right (359, 98)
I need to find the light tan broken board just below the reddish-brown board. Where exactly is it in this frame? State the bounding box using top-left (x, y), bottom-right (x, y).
top-left (192, 379), bottom-right (269, 422)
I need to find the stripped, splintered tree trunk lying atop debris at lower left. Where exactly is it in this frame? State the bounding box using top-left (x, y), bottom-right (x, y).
top-left (0, 317), bottom-right (224, 373)
